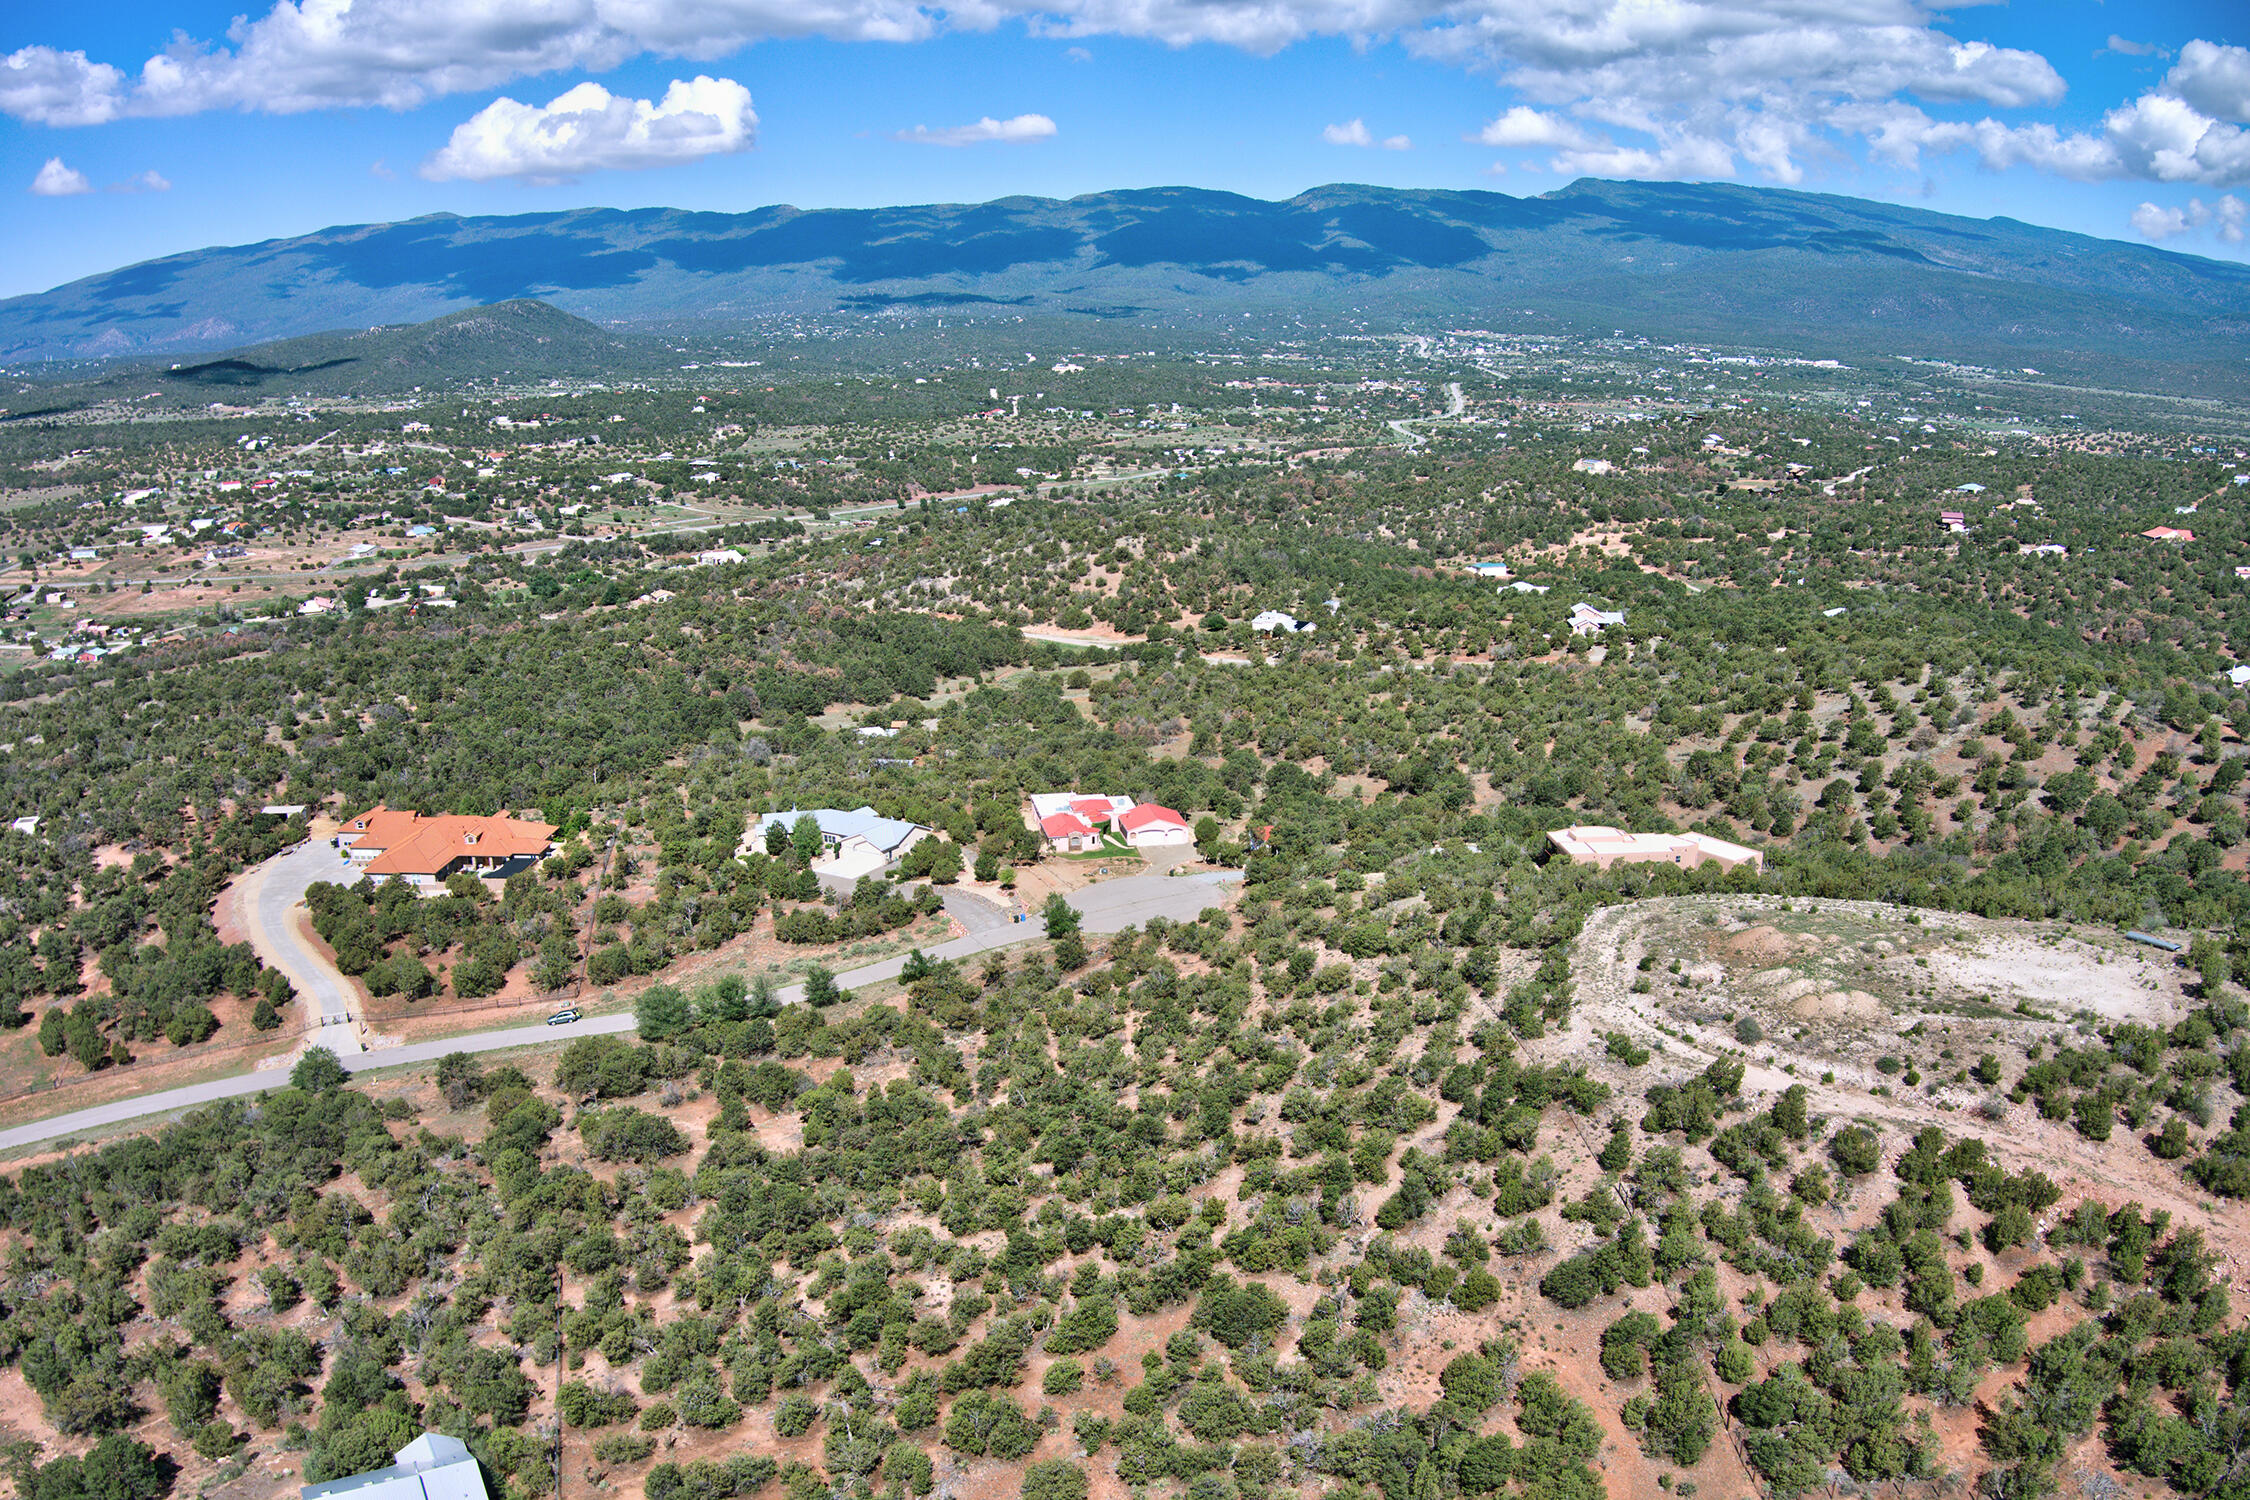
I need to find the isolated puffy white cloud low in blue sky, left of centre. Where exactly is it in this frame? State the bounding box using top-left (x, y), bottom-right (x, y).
top-left (421, 74), bottom-right (758, 182)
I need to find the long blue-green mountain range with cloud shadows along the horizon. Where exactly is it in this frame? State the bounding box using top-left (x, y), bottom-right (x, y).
top-left (0, 180), bottom-right (2250, 396)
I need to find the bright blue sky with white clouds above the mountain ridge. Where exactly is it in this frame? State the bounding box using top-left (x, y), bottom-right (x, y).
top-left (0, 0), bottom-right (2250, 295)
